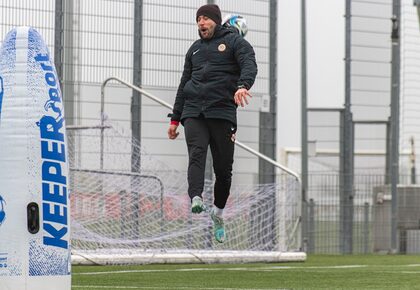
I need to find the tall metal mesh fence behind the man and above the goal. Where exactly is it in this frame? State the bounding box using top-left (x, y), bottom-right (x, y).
top-left (0, 0), bottom-right (276, 183)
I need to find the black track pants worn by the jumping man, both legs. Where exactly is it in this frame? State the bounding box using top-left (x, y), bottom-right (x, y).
top-left (184, 118), bottom-right (236, 208)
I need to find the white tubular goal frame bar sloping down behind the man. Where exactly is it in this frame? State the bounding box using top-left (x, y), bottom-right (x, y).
top-left (100, 77), bottom-right (301, 184)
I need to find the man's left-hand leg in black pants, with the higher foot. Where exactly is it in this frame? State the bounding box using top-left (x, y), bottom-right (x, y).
top-left (184, 118), bottom-right (210, 213)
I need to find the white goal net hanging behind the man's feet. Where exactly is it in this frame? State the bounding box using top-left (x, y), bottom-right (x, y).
top-left (68, 126), bottom-right (306, 264)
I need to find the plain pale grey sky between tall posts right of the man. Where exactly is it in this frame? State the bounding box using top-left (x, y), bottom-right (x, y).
top-left (278, 0), bottom-right (345, 149)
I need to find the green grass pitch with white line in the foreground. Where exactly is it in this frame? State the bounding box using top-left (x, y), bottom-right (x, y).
top-left (72, 255), bottom-right (420, 290)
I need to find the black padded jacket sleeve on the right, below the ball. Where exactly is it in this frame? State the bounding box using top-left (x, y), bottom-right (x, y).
top-left (234, 35), bottom-right (258, 90)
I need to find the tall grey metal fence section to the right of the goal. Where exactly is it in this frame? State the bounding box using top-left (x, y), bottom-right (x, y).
top-left (298, 0), bottom-right (420, 253)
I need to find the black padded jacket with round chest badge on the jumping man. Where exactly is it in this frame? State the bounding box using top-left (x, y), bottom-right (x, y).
top-left (171, 25), bottom-right (257, 126)
